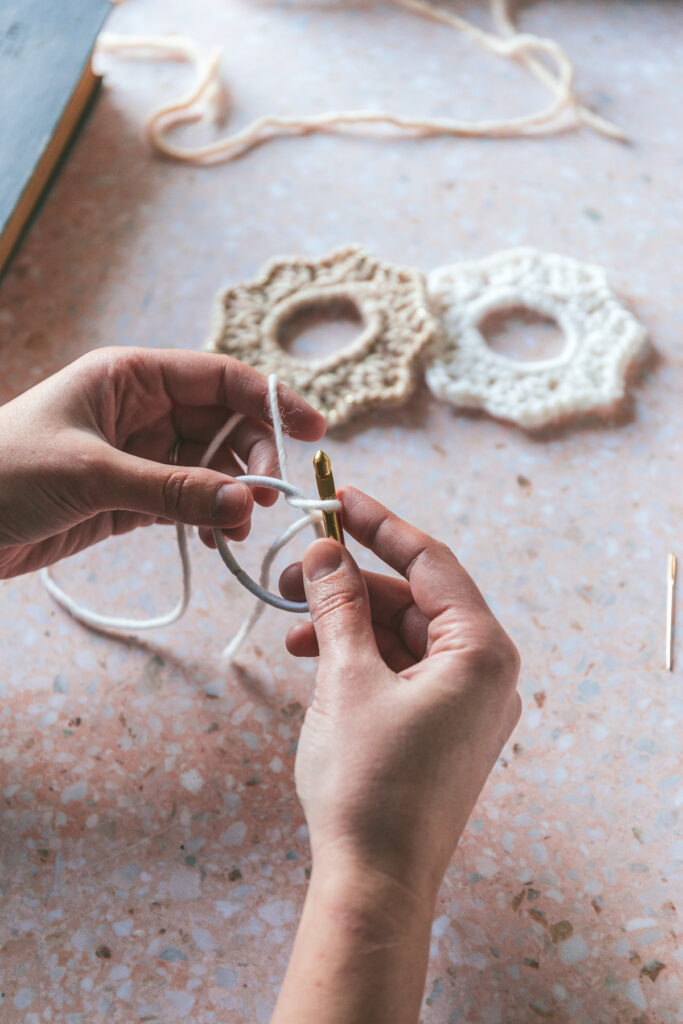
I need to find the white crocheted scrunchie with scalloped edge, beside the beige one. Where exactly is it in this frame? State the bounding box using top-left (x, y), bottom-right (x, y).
top-left (426, 249), bottom-right (645, 428)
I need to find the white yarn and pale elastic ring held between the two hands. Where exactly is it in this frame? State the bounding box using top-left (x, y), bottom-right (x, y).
top-left (40, 374), bottom-right (341, 663)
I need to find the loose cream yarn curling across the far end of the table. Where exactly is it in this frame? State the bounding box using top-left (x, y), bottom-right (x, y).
top-left (97, 0), bottom-right (626, 164)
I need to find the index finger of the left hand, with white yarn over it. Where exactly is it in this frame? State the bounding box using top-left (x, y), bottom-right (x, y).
top-left (127, 348), bottom-right (325, 441)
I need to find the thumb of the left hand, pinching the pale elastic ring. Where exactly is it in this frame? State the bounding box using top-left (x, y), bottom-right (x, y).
top-left (99, 452), bottom-right (254, 529)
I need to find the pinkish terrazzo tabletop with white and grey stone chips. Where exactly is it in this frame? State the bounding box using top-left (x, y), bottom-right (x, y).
top-left (0, 0), bottom-right (683, 1024)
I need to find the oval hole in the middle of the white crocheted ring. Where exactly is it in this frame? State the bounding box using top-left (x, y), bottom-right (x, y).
top-left (479, 306), bottom-right (566, 362)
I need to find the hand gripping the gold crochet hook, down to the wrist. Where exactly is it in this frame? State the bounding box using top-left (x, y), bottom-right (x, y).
top-left (281, 487), bottom-right (521, 901)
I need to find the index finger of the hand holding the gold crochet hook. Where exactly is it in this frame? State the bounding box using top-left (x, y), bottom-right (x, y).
top-left (337, 487), bottom-right (490, 618)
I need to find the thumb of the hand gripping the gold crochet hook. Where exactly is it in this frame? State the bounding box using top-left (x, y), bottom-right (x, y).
top-left (303, 540), bottom-right (379, 667)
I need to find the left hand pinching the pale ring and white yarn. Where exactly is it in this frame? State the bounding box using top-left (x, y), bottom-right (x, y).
top-left (0, 348), bottom-right (325, 578)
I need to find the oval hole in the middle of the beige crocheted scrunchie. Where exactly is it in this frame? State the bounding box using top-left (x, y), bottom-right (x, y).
top-left (278, 296), bottom-right (364, 360)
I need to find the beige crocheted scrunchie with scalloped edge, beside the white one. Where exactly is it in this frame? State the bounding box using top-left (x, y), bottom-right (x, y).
top-left (207, 246), bottom-right (437, 426)
